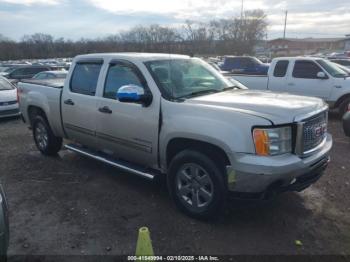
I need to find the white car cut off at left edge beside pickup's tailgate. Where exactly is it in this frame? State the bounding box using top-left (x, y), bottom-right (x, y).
top-left (0, 76), bottom-right (20, 118)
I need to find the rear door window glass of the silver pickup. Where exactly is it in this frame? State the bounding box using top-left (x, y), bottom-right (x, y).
top-left (70, 63), bottom-right (102, 96)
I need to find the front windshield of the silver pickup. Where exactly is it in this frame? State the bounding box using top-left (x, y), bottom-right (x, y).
top-left (145, 58), bottom-right (240, 99)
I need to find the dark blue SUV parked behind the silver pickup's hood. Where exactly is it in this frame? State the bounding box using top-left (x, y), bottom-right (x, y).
top-left (220, 56), bottom-right (269, 75)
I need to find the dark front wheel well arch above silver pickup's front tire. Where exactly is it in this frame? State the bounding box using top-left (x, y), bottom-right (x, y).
top-left (166, 138), bottom-right (230, 171)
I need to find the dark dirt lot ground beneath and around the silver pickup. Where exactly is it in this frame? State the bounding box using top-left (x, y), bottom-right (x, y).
top-left (0, 117), bottom-right (350, 255)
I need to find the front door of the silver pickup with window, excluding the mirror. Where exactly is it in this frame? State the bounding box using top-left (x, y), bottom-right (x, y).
top-left (96, 61), bottom-right (159, 166)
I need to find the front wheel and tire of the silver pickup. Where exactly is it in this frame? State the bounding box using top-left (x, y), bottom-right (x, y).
top-left (168, 150), bottom-right (227, 220)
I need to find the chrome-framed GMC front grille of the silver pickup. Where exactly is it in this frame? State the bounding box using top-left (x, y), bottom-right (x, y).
top-left (303, 111), bottom-right (328, 154)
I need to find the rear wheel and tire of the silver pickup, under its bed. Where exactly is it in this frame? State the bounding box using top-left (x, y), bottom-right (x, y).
top-left (32, 115), bottom-right (62, 156)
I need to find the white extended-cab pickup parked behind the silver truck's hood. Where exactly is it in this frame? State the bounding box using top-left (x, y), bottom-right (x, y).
top-left (233, 57), bottom-right (350, 115)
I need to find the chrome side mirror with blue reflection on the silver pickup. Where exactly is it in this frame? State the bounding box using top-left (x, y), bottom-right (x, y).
top-left (117, 84), bottom-right (152, 106)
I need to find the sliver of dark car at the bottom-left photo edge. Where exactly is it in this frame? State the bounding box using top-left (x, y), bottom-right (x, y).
top-left (0, 184), bottom-right (10, 261)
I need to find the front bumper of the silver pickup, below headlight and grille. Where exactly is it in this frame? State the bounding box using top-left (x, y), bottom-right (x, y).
top-left (227, 134), bottom-right (333, 194)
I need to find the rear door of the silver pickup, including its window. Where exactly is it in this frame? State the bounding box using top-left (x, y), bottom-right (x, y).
top-left (61, 60), bottom-right (103, 148)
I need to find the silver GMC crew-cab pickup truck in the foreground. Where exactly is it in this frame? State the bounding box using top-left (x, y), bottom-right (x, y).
top-left (18, 53), bottom-right (332, 218)
